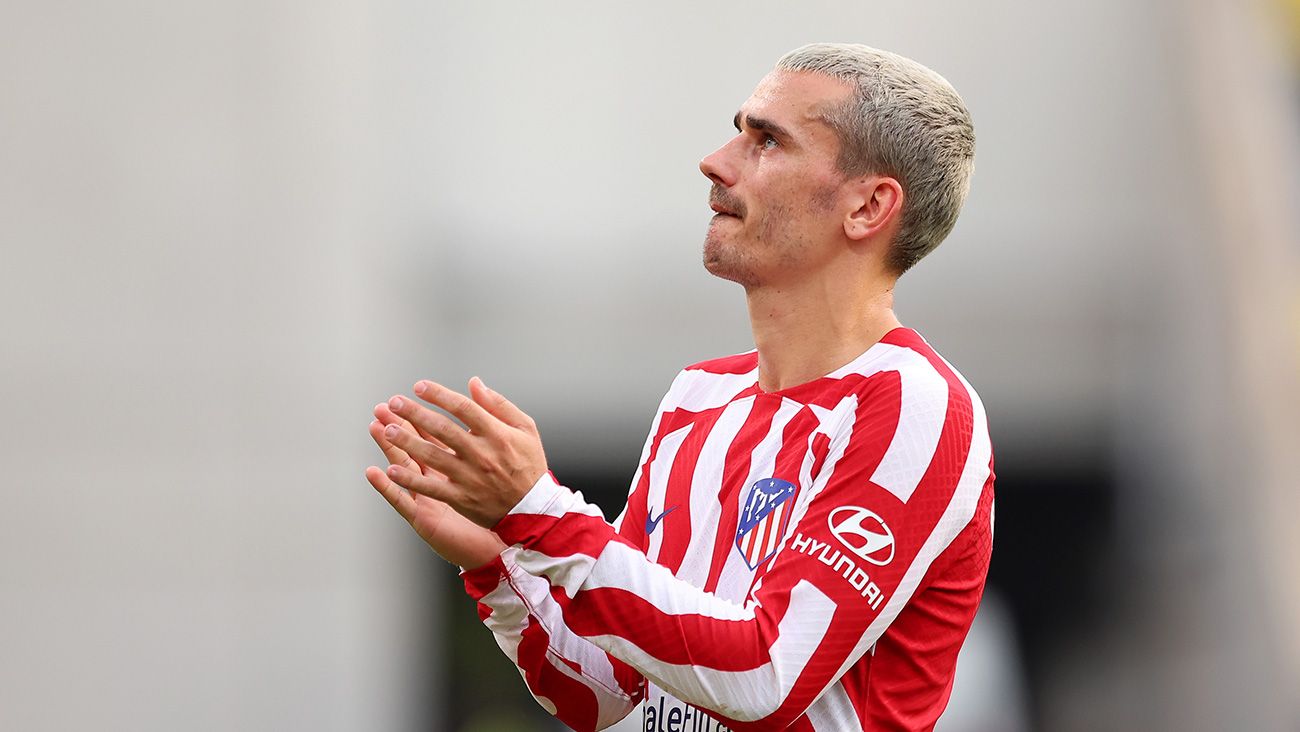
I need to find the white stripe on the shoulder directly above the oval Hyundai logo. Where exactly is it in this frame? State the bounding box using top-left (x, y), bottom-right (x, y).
top-left (871, 346), bottom-right (948, 503)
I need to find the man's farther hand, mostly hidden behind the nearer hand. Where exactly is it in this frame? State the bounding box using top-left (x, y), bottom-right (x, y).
top-left (365, 403), bottom-right (506, 569)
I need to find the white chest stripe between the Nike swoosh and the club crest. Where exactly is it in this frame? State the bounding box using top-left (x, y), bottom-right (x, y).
top-left (677, 398), bottom-right (754, 586)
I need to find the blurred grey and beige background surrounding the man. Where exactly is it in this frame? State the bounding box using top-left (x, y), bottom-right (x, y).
top-left (0, 0), bottom-right (1300, 732)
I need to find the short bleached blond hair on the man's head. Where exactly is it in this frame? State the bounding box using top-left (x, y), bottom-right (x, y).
top-left (776, 43), bottom-right (975, 274)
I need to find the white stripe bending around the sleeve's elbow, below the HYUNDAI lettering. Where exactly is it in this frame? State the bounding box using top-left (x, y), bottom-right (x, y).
top-left (590, 580), bottom-right (835, 722)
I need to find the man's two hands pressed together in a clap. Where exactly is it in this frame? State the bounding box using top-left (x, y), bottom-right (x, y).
top-left (365, 377), bottom-right (547, 568)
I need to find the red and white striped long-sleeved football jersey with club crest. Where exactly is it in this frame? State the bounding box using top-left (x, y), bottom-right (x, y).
top-left (464, 328), bottom-right (993, 732)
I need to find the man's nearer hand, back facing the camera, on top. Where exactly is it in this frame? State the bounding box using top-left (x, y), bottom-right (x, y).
top-left (384, 377), bottom-right (546, 528)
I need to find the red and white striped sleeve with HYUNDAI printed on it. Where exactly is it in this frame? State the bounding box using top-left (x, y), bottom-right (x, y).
top-left (495, 348), bottom-right (992, 731)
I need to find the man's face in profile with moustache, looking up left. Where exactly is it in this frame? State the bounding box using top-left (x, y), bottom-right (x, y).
top-left (699, 70), bottom-right (852, 289)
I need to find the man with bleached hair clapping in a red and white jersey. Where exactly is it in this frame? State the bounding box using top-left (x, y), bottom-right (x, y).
top-left (367, 44), bottom-right (993, 732)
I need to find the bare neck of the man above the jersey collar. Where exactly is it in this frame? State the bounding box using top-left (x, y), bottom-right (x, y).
top-left (746, 273), bottom-right (901, 391)
